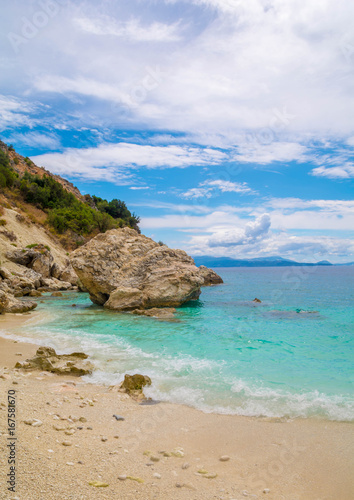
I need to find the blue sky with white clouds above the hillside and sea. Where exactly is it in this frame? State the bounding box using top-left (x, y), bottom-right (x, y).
top-left (0, 0), bottom-right (354, 262)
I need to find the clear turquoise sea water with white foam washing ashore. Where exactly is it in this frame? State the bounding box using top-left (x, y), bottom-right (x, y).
top-left (3, 267), bottom-right (354, 420)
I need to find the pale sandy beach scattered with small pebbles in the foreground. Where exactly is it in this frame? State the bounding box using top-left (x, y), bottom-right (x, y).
top-left (0, 315), bottom-right (354, 500)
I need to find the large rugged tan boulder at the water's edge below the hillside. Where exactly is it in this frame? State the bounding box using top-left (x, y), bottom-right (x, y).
top-left (71, 228), bottom-right (204, 310)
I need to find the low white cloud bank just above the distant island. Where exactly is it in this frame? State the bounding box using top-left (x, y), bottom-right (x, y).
top-left (142, 198), bottom-right (354, 261)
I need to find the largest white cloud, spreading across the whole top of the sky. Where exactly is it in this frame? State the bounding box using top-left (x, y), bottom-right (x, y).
top-left (0, 0), bottom-right (354, 145)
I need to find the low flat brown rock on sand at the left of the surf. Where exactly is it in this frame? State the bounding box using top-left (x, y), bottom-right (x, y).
top-left (15, 347), bottom-right (93, 376)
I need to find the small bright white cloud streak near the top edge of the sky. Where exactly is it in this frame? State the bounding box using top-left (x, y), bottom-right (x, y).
top-left (74, 16), bottom-right (181, 42)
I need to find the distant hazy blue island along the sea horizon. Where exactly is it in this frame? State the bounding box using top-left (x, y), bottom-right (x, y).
top-left (193, 255), bottom-right (354, 267)
